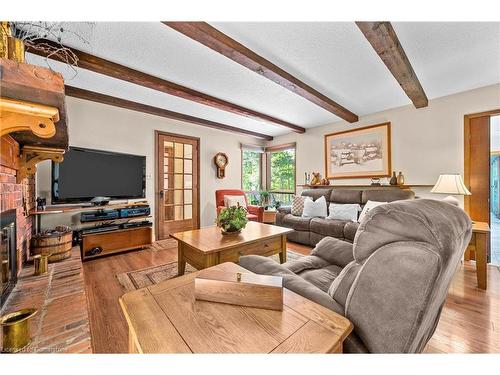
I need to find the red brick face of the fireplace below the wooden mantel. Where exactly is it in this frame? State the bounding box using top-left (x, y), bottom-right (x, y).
top-left (0, 136), bottom-right (36, 306)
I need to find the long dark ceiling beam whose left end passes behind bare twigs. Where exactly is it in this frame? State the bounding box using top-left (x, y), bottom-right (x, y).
top-left (26, 39), bottom-right (306, 133)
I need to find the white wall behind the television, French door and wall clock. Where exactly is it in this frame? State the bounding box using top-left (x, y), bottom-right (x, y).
top-left (37, 97), bottom-right (262, 234)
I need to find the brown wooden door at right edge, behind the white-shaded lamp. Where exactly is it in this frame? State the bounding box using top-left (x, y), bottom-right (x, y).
top-left (464, 115), bottom-right (490, 223)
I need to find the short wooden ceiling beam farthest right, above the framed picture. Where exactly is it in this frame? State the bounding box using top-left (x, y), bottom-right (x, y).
top-left (356, 22), bottom-right (429, 108)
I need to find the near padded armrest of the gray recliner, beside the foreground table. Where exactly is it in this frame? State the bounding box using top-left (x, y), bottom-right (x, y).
top-left (239, 255), bottom-right (344, 315)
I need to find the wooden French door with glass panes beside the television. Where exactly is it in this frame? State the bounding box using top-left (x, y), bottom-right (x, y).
top-left (156, 131), bottom-right (200, 240)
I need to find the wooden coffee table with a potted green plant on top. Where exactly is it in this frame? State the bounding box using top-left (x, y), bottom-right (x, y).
top-left (170, 221), bottom-right (292, 275)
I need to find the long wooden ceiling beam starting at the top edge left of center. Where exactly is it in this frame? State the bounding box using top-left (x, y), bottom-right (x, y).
top-left (163, 22), bottom-right (358, 122)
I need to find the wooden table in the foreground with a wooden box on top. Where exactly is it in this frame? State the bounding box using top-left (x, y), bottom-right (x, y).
top-left (120, 263), bottom-right (352, 353)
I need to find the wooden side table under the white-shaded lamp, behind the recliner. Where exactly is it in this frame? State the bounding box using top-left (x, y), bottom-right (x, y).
top-left (464, 222), bottom-right (490, 290)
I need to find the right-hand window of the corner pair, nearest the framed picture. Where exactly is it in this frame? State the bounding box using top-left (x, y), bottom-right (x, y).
top-left (266, 143), bottom-right (295, 203)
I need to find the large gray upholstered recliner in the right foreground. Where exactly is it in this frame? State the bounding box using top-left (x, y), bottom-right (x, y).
top-left (240, 199), bottom-right (472, 353)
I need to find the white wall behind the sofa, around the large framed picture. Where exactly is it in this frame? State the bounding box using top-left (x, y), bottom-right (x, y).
top-left (267, 85), bottom-right (500, 204)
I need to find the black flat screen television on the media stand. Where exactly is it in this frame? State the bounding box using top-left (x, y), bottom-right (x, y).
top-left (52, 147), bottom-right (146, 204)
